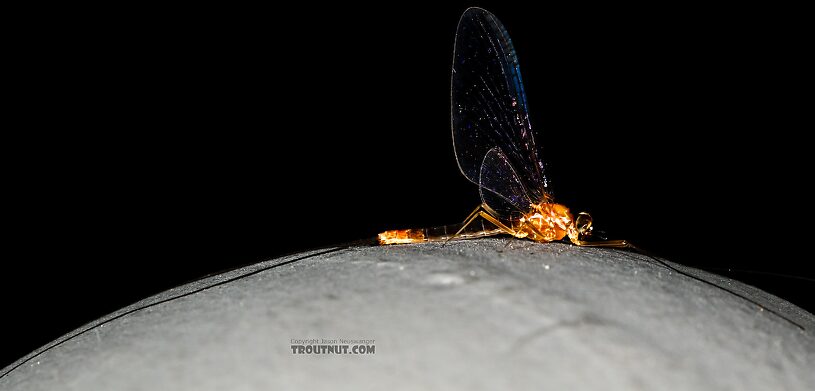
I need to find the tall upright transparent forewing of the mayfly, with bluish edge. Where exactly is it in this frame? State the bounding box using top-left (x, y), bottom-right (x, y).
top-left (451, 8), bottom-right (548, 202)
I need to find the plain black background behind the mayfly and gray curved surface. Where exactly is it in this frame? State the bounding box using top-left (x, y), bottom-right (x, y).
top-left (0, 2), bottom-right (815, 366)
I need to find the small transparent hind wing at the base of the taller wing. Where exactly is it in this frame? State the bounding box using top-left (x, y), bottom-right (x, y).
top-left (478, 147), bottom-right (531, 217)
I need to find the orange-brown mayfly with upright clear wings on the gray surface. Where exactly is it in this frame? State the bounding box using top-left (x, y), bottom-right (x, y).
top-left (378, 8), bottom-right (629, 247)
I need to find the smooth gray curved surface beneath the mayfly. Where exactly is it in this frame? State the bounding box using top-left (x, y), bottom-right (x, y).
top-left (0, 239), bottom-right (815, 390)
